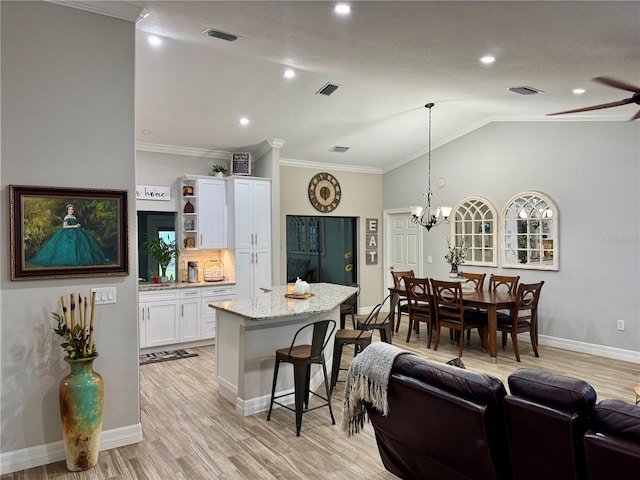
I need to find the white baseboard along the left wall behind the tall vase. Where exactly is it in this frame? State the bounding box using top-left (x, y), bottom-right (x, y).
top-left (0, 423), bottom-right (142, 474)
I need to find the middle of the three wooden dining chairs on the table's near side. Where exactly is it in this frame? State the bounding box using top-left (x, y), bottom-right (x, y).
top-left (431, 279), bottom-right (487, 357)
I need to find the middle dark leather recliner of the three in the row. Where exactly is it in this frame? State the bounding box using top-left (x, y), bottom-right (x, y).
top-left (505, 368), bottom-right (596, 480)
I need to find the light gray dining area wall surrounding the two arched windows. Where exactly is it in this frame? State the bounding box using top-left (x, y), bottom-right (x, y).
top-left (383, 121), bottom-right (640, 361)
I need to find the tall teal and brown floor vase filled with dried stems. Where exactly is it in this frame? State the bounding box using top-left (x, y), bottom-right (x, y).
top-left (51, 292), bottom-right (104, 472)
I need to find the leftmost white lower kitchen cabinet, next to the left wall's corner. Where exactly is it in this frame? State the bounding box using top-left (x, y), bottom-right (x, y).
top-left (138, 290), bottom-right (179, 348)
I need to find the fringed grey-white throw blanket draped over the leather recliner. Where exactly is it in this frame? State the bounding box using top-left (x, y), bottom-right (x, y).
top-left (342, 342), bottom-right (415, 436)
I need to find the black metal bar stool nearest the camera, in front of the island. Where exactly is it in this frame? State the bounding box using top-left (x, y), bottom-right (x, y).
top-left (267, 320), bottom-right (336, 437)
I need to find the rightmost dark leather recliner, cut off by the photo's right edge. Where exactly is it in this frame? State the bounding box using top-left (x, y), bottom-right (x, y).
top-left (584, 400), bottom-right (640, 480)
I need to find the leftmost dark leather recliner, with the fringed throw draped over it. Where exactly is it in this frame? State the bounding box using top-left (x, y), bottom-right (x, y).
top-left (367, 355), bottom-right (512, 480)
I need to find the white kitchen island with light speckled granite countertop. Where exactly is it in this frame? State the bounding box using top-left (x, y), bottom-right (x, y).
top-left (209, 283), bottom-right (356, 416)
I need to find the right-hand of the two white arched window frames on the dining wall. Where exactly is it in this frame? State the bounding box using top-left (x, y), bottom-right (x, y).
top-left (502, 192), bottom-right (558, 270)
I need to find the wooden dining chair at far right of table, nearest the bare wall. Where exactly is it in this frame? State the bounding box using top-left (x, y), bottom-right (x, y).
top-left (497, 281), bottom-right (544, 362)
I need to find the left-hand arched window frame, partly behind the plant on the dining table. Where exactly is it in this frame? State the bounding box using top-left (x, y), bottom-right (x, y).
top-left (451, 197), bottom-right (498, 267)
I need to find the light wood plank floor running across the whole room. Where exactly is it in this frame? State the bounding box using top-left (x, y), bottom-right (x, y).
top-left (1, 320), bottom-right (640, 480)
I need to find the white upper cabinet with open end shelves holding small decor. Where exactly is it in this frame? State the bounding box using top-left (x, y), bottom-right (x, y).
top-left (178, 175), bottom-right (227, 249)
